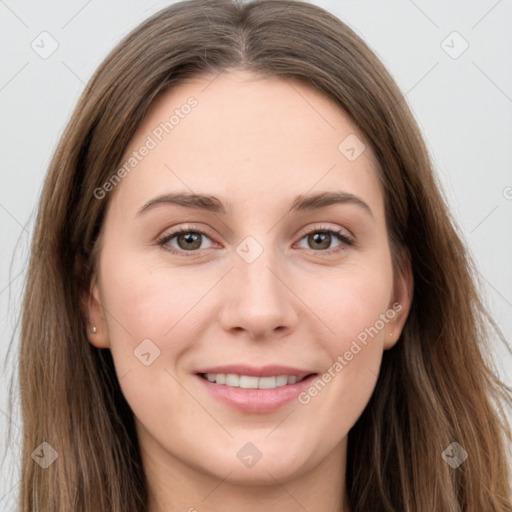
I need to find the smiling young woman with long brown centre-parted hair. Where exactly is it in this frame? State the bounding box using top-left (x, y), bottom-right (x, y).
top-left (10, 0), bottom-right (512, 512)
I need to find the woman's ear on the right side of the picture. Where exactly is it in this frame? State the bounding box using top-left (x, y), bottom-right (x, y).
top-left (384, 249), bottom-right (414, 350)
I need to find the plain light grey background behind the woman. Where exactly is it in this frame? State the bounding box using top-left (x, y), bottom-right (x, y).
top-left (0, 0), bottom-right (512, 511)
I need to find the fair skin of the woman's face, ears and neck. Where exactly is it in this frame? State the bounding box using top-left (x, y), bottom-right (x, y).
top-left (87, 71), bottom-right (412, 512)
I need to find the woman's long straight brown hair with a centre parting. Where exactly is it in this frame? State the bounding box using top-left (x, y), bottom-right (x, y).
top-left (9, 0), bottom-right (512, 512)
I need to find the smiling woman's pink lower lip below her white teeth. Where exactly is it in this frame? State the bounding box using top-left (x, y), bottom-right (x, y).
top-left (196, 374), bottom-right (316, 413)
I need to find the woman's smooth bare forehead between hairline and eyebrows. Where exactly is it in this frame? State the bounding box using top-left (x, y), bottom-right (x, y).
top-left (106, 71), bottom-right (381, 218)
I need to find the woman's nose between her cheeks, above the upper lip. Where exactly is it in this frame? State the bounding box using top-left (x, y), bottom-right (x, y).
top-left (220, 247), bottom-right (299, 339)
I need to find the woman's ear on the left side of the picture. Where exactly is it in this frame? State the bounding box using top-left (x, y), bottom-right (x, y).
top-left (75, 255), bottom-right (110, 348)
